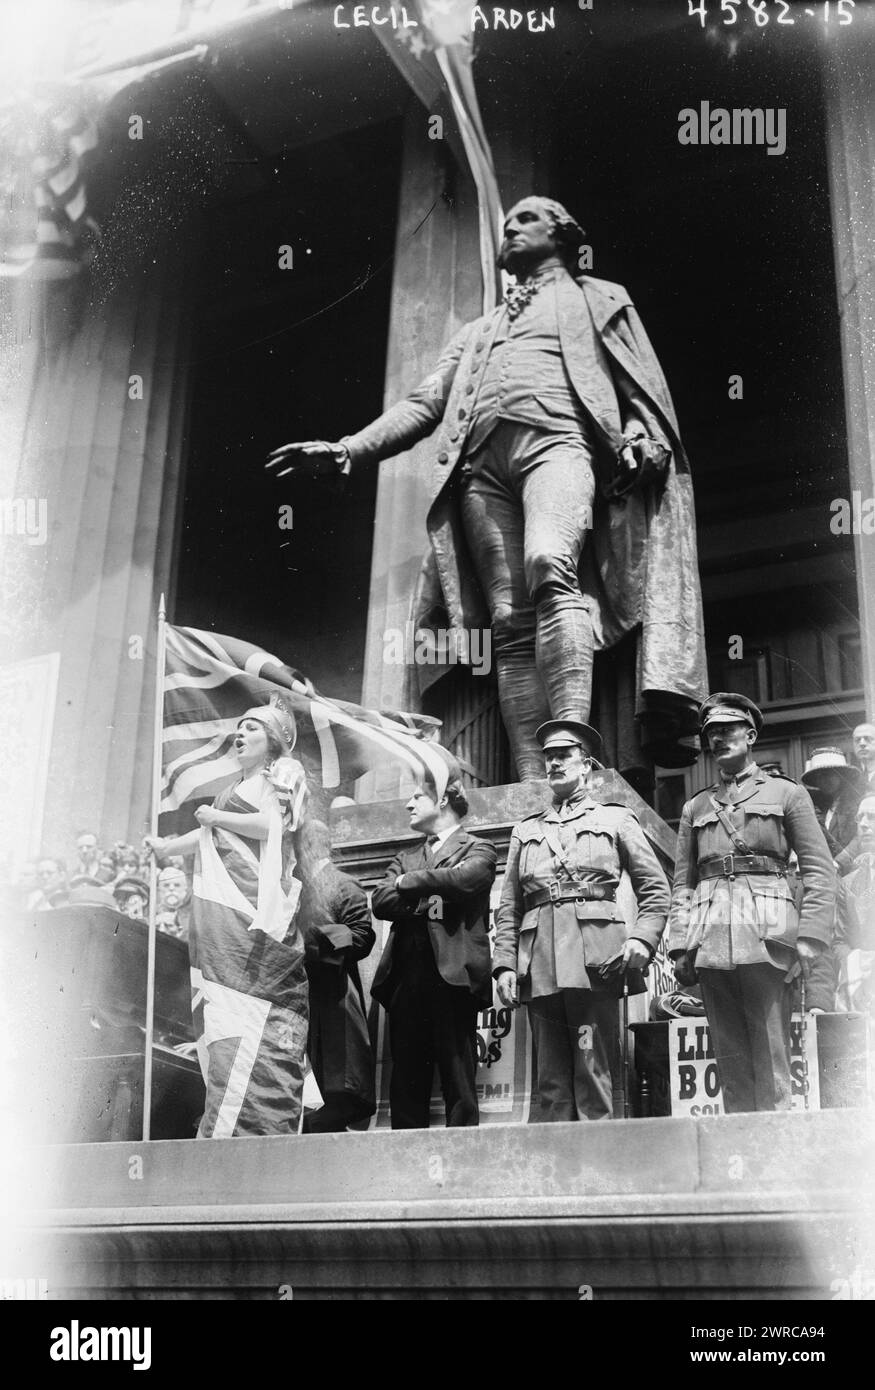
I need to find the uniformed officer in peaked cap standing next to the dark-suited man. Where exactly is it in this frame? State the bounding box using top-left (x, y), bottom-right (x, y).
top-left (492, 720), bottom-right (669, 1122)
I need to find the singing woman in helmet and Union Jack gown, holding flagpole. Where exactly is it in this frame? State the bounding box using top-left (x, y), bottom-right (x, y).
top-left (146, 701), bottom-right (307, 1138)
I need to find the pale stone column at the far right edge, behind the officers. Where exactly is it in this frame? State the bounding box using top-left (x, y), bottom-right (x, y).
top-left (824, 16), bottom-right (875, 719)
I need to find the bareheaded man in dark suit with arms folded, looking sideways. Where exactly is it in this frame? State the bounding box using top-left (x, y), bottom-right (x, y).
top-left (371, 749), bottom-right (497, 1129)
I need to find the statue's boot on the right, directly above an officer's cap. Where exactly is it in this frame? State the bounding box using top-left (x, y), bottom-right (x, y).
top-left (536, 592), bottom-right (593, 723)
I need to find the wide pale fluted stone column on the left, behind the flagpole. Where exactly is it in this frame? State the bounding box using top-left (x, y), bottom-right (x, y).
top-left (0, 259), bottom-right (189, 855)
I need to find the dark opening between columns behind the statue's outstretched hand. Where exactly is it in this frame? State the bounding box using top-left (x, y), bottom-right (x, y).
top-left (174, 122), bottom-right (399, 699)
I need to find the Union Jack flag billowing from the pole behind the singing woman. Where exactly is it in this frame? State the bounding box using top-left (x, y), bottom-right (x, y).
top-left (160, 624), bottom-right (445, 835)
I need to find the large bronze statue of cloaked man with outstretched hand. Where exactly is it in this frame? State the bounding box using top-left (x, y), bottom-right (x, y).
top-left (267, 197), bottom-right (707, 780)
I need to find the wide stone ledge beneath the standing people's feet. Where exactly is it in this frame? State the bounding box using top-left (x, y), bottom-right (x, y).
top-left (18, 1111), bottom-right (875, 1302)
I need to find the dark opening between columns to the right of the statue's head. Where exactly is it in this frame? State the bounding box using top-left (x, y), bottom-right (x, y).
top-left (479, 16), bottom-right (861, 701)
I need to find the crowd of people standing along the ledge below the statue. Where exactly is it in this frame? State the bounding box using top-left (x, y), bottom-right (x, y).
top-left (8, 706), bottom-right (875, 1137)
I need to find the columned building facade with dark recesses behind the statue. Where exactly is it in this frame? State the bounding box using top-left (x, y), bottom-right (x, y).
top-left (0, 4), bottom-right (875, 853)
